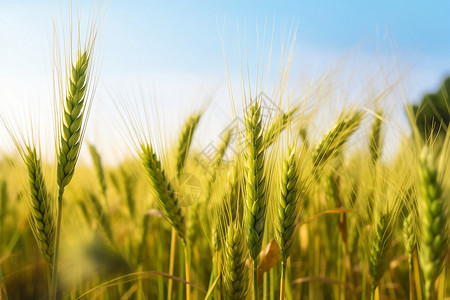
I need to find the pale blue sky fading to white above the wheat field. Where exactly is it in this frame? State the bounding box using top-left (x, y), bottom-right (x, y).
top-left (0, 0), bottom-right (450, 162)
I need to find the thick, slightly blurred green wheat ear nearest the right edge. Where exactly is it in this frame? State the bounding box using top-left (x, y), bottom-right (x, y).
top-left (418, 148), bottom-right (447, 299)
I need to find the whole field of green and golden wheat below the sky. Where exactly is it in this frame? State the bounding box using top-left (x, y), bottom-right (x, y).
top-left (0, 3), bottom-right (450, 300)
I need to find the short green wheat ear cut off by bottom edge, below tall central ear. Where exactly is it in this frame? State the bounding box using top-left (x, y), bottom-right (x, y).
top-left (223, 224), bottom-right (248, 299)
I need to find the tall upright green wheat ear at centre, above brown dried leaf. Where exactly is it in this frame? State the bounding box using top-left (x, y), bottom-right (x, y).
top-left (245, 102), bottom-right (267, 261)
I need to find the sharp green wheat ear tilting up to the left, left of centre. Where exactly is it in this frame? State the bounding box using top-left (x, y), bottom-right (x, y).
top-left (141, 145), bottom-right (186, 241)
